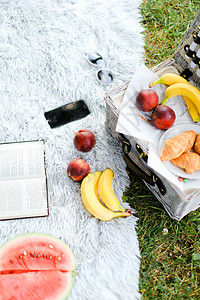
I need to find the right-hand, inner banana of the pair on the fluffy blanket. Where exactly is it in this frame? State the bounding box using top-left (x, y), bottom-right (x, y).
top-left (98, 169), bottom-right (125, 211)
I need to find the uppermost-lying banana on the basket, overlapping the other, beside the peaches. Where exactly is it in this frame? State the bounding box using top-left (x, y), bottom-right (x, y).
top-left (162, 83), bottom-right (200, 113)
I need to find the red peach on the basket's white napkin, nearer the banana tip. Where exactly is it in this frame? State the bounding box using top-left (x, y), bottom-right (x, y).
top-left (135, 89), bottom-right (159, 112)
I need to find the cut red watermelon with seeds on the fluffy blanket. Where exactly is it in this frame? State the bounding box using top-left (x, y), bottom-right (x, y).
top-left (0, 233), bottom-right (75, 300)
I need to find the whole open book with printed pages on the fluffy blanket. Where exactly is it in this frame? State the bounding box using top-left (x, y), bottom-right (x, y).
top-left (0, 141), bottom-right (48, 220)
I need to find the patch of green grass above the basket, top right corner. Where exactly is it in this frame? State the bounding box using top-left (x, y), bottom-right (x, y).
top-left (141, 0), bottom-right (200, 67)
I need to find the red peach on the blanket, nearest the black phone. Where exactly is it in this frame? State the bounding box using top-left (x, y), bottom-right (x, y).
top-left (73, 129), bottom-right (96, 152)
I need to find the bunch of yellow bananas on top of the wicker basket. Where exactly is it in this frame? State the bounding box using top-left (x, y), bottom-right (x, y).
top-left (149, 73), bottom-right (200, 123)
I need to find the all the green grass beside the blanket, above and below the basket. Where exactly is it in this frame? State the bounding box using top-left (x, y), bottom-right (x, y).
top-left (124, 0), bottom-right (200, 300)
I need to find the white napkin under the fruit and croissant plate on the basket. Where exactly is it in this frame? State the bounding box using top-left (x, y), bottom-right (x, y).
top-left (116, 65), bottom-right (200, 194)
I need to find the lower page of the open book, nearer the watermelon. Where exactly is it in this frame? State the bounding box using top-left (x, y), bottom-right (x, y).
top-left (0, 178), bottom-right (48, 219)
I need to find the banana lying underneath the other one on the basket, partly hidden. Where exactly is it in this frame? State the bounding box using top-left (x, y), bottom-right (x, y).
top-left (149, 73), bottom-right (200, 122)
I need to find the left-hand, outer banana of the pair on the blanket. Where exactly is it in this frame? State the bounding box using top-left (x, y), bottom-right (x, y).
top-left (81, 171), bottom-right (131, 221)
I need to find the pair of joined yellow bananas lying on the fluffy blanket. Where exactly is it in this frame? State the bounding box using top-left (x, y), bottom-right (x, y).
top-left (81, 169), bottom-right (131, 221)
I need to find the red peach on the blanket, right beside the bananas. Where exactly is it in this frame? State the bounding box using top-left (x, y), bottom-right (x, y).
top-left (67, 158), bottom-right (90, 181)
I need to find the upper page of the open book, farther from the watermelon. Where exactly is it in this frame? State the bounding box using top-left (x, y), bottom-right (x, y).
top-left (0, 141), bottom-right (45, 180)
